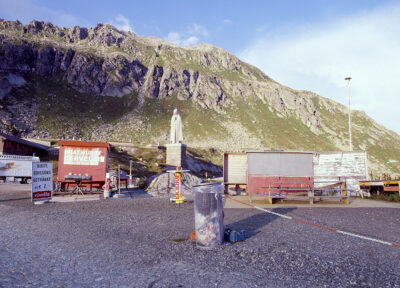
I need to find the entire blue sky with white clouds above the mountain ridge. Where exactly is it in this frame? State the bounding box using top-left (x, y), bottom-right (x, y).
top-left (0, 0), bottom-right (400, 134)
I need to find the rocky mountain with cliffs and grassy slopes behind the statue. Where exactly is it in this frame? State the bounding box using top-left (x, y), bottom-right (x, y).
top-left (0, 20), bottom-right (400, 174)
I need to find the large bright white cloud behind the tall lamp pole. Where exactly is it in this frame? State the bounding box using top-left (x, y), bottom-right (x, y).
top-left (239, 4), bottom-right (400, 133)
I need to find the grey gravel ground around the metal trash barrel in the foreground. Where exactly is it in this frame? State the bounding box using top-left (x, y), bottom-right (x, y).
top-left (0, 184), bottom-right (400, 287)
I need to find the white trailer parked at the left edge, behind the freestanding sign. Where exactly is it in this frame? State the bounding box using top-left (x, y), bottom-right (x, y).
top-left (0, 155), bottom-right (40, 184)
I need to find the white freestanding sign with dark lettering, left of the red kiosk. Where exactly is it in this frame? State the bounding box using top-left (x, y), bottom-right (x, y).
top-left (32, 162), bottom-right (53, 202)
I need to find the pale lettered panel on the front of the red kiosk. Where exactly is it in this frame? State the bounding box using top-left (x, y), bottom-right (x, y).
top-left (64, 147), bottom-right (104, 166)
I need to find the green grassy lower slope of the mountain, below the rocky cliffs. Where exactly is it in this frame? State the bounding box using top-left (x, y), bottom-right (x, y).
top-left (8, 77), bottom-right (400, 173)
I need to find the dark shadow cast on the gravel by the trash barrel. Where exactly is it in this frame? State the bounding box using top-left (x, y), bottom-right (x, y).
top-left (227, 208), bottom-right (297, 238)
